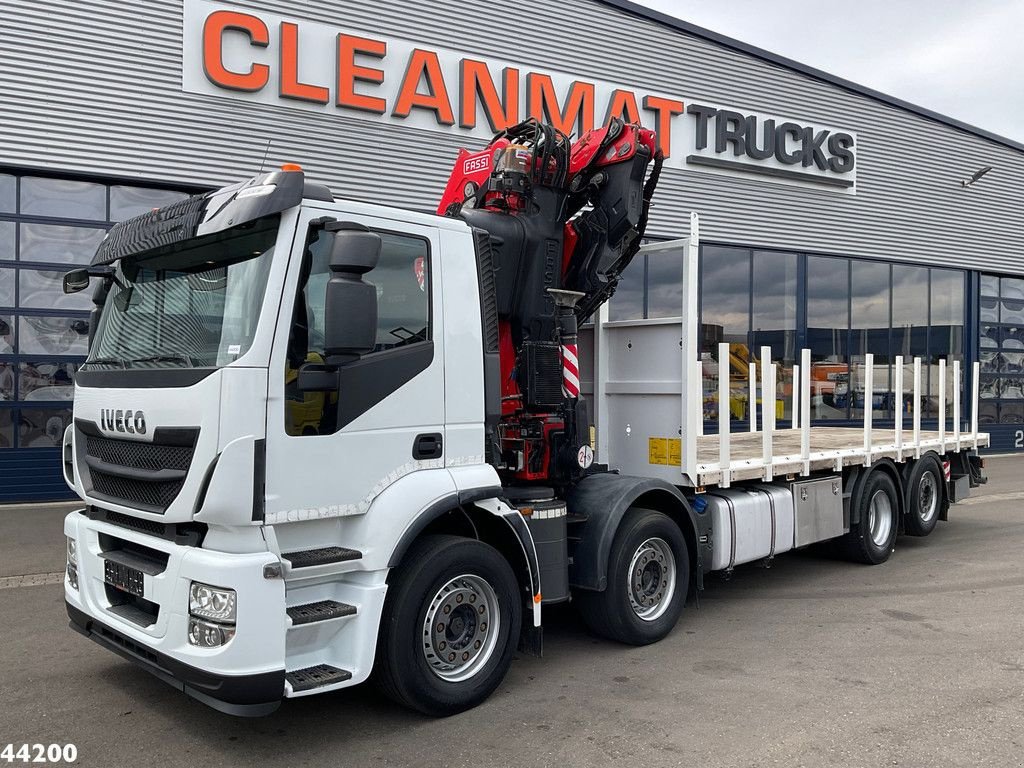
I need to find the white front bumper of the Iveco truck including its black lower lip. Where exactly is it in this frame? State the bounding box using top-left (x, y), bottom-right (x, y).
top-left (65, 512), bottom-right (288, 716)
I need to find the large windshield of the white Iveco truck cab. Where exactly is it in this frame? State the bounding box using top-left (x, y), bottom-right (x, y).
top-left (85, 215), bottom-right (281, 370)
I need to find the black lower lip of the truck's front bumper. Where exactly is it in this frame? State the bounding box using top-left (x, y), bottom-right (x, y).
top-left (65, 601), bottom-right (285, 717)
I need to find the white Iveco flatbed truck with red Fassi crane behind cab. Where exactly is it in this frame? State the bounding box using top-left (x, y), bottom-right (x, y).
top-left (63, 125), bottom-right (987, 715)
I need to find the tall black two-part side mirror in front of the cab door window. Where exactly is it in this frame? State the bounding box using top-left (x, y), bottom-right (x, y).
top-left (324, 222), bottom-right (381, 366)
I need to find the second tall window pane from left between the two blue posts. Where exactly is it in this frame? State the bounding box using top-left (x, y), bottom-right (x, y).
top-left (850, 259), bottom-right (892, 419)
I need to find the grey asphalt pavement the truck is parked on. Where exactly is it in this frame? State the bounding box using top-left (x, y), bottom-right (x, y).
top-left (0, 458), bottom-right (1024, 768)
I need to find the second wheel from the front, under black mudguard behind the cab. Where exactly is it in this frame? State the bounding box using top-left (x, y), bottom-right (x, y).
top-left (575, 507), bottom-right (690, 645)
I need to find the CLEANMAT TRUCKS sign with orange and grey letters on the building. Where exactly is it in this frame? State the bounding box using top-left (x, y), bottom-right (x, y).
top-left (182, 0), bottom-right (857, 191)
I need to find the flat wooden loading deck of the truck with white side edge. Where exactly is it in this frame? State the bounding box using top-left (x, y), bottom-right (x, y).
top-left (696, 427), bottom-right (988, 485)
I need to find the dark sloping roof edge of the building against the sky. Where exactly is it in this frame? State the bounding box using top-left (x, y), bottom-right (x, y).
top-left (597, 0), bottom-right (1024, 152)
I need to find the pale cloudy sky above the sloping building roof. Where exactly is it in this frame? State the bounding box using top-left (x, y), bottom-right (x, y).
top-left (638, 0), bottom-right (1024, 141)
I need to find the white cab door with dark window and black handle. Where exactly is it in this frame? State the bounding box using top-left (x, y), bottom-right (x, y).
top-left (265, 210), bottom-right (444, 522)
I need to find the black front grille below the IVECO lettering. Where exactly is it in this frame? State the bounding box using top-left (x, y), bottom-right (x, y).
top-left (76, 428), bottom-right (199, 518)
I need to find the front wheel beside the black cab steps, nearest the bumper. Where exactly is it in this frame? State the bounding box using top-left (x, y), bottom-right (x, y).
top-left (374, 536), bottom-right (522, 717)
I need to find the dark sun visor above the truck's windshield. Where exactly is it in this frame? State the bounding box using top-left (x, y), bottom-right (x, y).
top-left (91, 171), bottom-right (305, 266)
